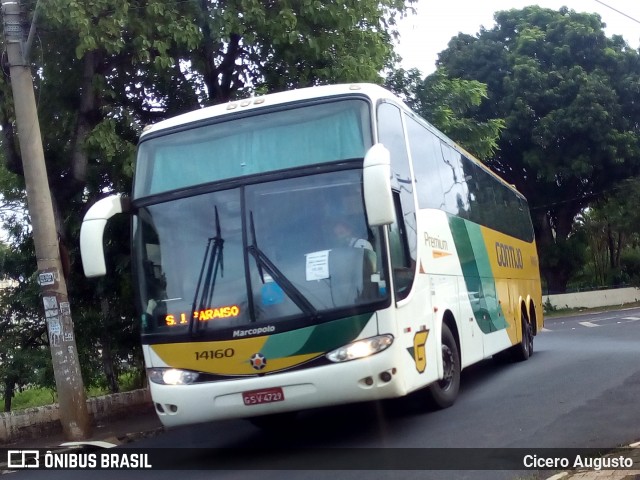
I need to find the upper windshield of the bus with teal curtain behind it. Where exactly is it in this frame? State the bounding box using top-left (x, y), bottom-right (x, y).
top-left (133, 99), bottom-right (372, 198)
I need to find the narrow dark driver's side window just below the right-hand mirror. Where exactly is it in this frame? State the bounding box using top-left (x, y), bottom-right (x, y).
top-left (389, 192), bottom-right (414, 300)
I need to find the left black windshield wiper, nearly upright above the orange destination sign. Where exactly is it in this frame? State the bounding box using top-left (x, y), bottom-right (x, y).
top-left (189, 206), bottom-right (224, 334)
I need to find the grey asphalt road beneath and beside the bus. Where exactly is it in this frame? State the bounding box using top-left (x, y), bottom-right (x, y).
top-left (12, 309), bottom-right (640, 480)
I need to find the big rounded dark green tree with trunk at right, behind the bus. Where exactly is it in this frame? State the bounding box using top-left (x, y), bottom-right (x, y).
top-left (438, 6), bottom-right (640, 291)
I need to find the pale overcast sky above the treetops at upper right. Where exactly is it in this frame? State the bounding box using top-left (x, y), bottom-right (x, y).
top-left (396, 0), bottom-right (640, 75)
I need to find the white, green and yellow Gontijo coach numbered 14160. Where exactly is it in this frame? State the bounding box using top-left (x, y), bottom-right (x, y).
top-left (81, 84), bottom-right (543, 426)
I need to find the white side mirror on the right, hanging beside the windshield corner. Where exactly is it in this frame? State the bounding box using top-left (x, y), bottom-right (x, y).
top-left (362, 143), bottom-right (396, 227)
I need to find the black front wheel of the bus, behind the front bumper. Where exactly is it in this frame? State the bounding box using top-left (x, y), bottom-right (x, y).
top-left (427, 324), bottom-right (460, 408)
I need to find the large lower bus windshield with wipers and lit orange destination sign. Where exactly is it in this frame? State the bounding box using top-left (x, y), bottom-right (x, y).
top-left (134, 169), bottom-right (388, 338)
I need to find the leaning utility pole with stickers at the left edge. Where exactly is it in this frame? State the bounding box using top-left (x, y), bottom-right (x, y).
top-left (2, 0), bottom-right (91, 440)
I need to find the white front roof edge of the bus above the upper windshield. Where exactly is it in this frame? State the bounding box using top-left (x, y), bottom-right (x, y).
top-left (141, 83), bottom-right (403, 139)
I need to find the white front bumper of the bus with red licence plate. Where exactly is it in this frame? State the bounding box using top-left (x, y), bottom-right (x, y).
top-left (150, 349), bottom-right (406, 427)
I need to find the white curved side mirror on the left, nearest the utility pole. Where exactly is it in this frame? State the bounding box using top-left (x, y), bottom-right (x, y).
top-left (80, 195), bottom-right (129, 278)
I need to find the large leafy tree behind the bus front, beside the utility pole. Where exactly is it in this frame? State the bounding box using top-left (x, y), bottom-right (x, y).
top-left (28, 0), bottom-right (413, 199)
